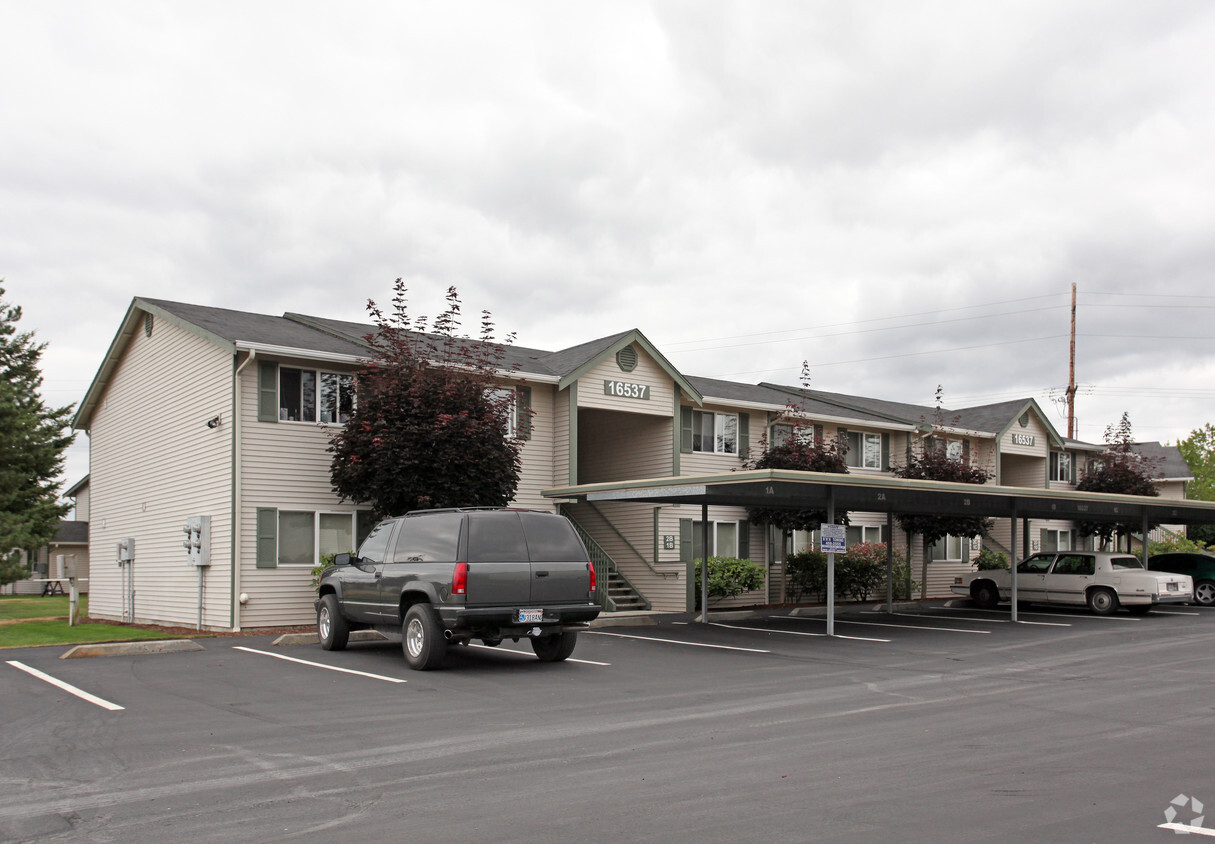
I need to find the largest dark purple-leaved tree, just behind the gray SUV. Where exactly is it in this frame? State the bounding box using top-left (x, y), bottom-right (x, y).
top-left (329, 279), bottom-right (530, 516)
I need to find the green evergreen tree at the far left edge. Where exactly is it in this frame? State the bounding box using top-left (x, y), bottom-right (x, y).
top-left (0, 287), bottom-right (74, 584)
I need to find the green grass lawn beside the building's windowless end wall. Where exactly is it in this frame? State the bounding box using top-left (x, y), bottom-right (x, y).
top-left (0, 595), bottom-right (189, 648)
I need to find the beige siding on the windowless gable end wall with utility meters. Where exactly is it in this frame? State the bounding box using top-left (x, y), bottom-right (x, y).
top-left (89, 319), bottom-right (232, 628)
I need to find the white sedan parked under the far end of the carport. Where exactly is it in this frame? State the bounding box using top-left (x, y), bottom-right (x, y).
top-left (951, 551), bottom-right (1194, 616)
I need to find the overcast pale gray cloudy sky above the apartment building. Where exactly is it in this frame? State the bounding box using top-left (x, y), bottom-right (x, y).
top-left (0, 0), bottom-right (1215, 483)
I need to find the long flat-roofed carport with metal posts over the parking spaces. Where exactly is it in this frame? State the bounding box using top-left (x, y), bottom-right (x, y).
top-left (543, 469), bottom-right (1215, 635)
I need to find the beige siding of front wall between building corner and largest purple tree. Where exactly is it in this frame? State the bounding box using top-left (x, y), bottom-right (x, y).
top-left (238, 359), bottom-right (360, 628)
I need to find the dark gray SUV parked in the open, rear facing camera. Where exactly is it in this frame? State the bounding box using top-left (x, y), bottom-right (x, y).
top-left (316, 508), bottom-right (599, 670)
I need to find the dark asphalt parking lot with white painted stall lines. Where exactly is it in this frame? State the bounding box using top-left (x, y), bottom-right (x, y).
top-left (0, 602), bottom-right (1215, 842)
